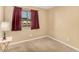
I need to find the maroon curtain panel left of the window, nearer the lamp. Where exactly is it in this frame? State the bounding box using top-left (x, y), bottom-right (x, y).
top-left (12, 7), bottom-right (22, 31)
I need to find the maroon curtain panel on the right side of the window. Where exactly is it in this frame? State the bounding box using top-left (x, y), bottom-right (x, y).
top-left (31, 10), bottom-right (39, 29)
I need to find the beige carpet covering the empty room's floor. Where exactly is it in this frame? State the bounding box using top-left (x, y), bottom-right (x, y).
top-left (8, 37), bottom-right (75, 52)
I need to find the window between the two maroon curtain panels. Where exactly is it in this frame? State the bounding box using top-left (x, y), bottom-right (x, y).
top-left (22, 10), bottom-right (31, 28)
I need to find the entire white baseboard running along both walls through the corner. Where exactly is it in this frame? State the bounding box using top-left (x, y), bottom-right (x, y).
top-left (10, 35), bottom-right (79, 51)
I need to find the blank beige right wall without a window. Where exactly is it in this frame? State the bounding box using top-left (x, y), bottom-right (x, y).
top-left (48, 6), bottom-right (79, 48)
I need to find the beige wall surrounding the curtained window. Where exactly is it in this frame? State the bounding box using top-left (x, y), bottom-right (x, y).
top-left (5, 6), bottom-right (47, 42)
